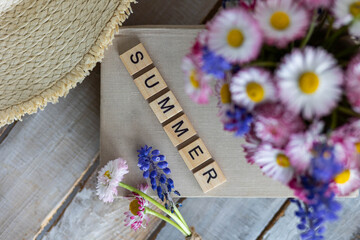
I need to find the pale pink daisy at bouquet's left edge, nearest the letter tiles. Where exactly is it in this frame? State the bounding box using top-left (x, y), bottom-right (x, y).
top-left (182, 56), bottom-right (212, 104)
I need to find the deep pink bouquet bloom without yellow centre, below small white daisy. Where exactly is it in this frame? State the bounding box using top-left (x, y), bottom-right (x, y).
top-left (253, 103), bottom-right (304, 147)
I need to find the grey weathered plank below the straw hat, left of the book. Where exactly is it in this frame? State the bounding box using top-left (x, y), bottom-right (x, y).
top-left (0, 64), bottom-right (100, 240)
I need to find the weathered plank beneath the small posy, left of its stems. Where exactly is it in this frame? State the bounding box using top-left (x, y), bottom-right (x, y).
top-left (43, 173), bottom-right (159, 240)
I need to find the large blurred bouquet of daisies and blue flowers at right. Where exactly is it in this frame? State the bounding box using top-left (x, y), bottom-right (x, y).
top-left (182, 0), bottom-right (360, 239)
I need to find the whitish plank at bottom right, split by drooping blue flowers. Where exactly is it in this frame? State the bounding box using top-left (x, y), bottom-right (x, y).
top-left (264, 197), bottom-right (360, 240)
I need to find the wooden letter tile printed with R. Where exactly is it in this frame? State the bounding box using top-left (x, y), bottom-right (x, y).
top-left (194, 162), bottom-right (226, 193)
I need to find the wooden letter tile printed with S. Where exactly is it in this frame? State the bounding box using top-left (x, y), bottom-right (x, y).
top-left (120, 43), bottom-right (152, 76)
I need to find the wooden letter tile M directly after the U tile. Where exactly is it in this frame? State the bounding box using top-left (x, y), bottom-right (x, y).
top-left (149, 91), bottom-right (182, 123)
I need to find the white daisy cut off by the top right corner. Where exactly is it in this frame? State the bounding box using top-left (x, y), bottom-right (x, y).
top-left (333, 0), bottom-right (360, 37)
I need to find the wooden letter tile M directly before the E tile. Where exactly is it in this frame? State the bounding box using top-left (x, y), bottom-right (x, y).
top-left (164, 114), bottom-right (196, 147)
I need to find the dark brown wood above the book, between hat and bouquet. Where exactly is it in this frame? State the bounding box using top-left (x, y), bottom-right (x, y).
top-left (124, 0), bottom-right (221, 26)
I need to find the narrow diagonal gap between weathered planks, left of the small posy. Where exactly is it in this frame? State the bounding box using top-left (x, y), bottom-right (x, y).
top-left (33, 152), bottom-right (100, 240)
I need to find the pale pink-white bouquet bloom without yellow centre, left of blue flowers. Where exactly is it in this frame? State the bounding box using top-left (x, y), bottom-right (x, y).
top-left (285, 122), bottom-right (325, 172)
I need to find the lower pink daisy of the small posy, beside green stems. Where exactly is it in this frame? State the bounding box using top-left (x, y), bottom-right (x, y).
top-left (124, 184), bottom-right (149, 231)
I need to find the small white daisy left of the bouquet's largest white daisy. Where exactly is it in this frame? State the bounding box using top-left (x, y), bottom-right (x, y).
top-left (230, 68), bottom-right (275, 110)
